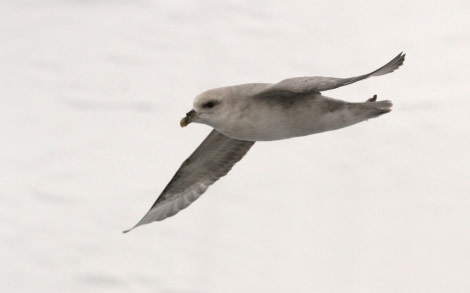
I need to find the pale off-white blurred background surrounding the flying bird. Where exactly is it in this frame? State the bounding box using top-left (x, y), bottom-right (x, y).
top-left (0, 0), bottom-right (470, 293)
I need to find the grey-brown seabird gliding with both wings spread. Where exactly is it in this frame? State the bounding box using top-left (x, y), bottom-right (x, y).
top-left (124, 53), bottom-right (405, 232)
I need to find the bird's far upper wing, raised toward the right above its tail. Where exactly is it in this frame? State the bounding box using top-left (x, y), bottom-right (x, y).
top-left (255, 52), bottom-right (405, 97)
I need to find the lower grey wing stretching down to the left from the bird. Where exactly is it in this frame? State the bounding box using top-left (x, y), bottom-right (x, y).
top-left (124, 129), bottom-right (255, 232)
